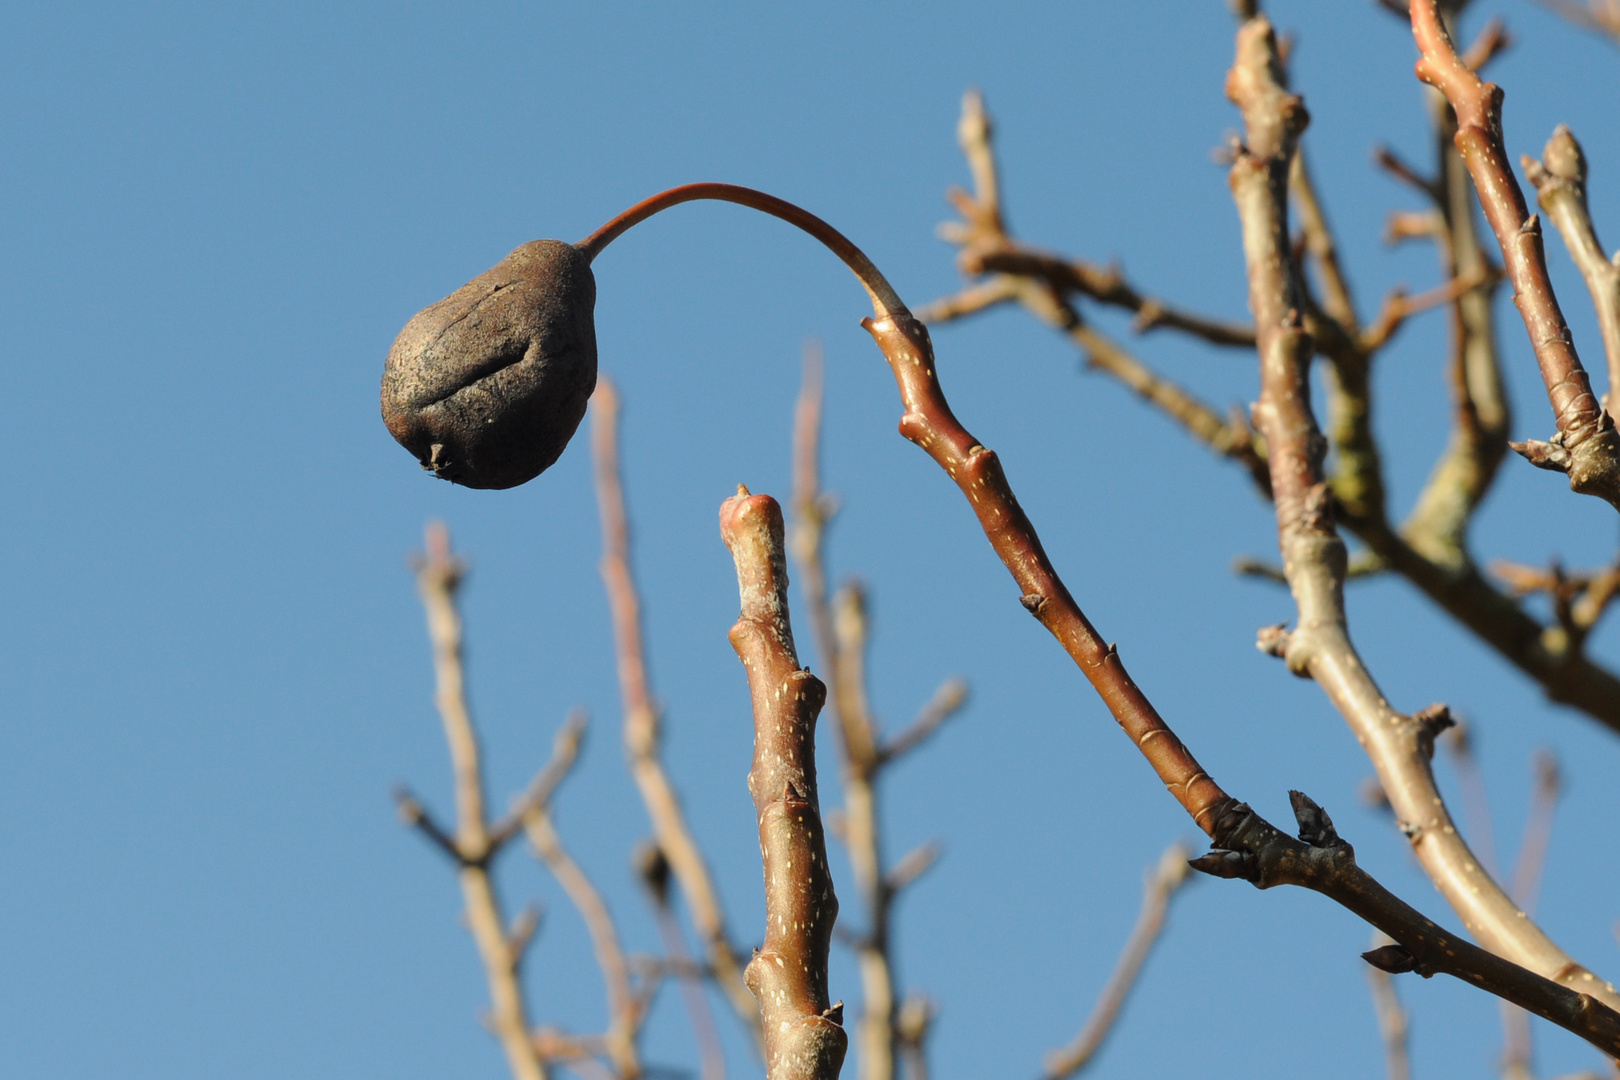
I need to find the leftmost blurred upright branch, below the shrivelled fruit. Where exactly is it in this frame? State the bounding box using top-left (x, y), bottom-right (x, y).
top-left (402, 523), bottom-right (546, 1080)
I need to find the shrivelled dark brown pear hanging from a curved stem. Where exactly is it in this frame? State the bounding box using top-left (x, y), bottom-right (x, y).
top-left (382, 240), bottom-right (596, 487)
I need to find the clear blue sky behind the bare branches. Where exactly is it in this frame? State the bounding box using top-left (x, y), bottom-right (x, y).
top-left (0, 0), bottom-right (1620, 1080)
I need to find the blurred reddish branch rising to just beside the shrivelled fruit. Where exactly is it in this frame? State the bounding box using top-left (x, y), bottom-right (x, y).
top-left (591, 377), bottom-right (760, 1041)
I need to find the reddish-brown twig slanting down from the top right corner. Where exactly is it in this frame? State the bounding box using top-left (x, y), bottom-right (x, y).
top-left (1411, 0), bottom-right (1620, 508)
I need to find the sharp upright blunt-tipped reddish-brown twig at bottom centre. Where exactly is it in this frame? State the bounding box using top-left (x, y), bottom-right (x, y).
top-left (719, 486), bottom-right (849, 1080)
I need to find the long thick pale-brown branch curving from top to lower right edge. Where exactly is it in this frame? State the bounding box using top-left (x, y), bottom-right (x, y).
top-left (1226, 18), bottom-right (1620, 1007)
